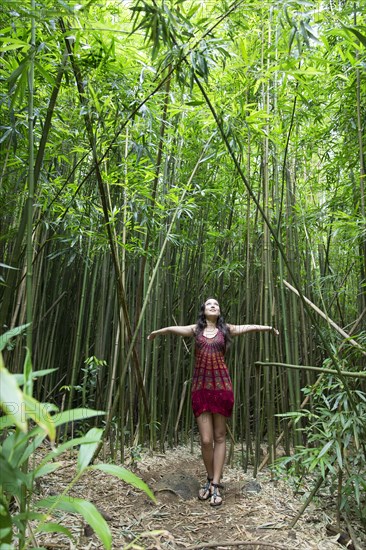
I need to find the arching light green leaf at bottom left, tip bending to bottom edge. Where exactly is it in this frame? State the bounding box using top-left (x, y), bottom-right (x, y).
top-left (36, 495), bottom-right (112, 550)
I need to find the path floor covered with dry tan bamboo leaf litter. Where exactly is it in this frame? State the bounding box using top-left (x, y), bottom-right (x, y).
top-left (37, 447), bottom-right (366, 550)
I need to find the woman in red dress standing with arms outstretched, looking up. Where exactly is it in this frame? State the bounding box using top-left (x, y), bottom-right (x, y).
top-left (148, 298), bottom-right (279, 506)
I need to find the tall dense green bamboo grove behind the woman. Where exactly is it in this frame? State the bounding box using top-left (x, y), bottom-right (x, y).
top-left (0, 0), bottom-right (366, 536)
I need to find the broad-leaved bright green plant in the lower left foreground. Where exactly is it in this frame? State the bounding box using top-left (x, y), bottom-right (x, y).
top-left (0, 327), bottom-right (155, 550)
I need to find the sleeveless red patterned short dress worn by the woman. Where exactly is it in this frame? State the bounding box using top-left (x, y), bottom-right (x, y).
top-left (192, 330), bottom-right (234, 417)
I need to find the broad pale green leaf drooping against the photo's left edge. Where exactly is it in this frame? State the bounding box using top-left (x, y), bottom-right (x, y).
top-left (0, 360), bottom-right (27, 432)
